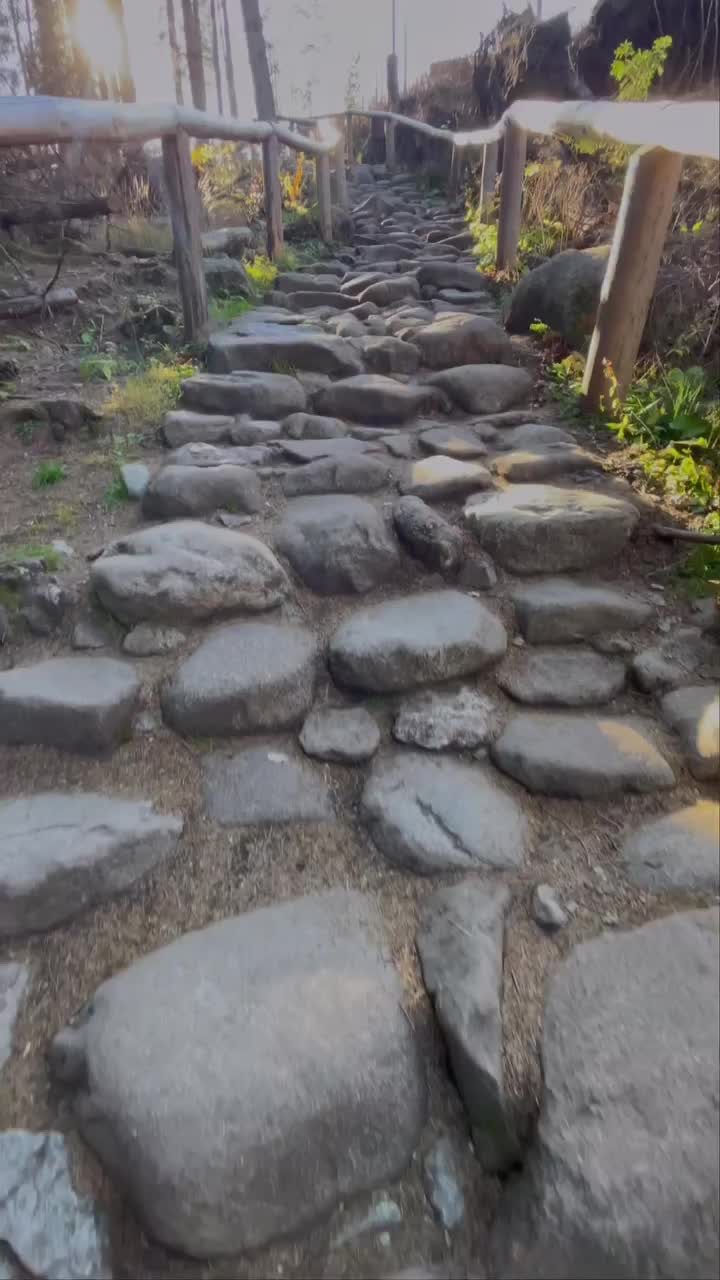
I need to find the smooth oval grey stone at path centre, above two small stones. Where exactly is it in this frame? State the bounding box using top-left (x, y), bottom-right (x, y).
top-left (329, 590), bottom-right (507, 694)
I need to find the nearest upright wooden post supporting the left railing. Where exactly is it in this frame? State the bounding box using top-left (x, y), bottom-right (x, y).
top-left (163, 129), bottom-right (208, 342)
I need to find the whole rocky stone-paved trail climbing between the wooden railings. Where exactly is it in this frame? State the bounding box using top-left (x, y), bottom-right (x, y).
top-left (0, 168), bottom-right (720, 1280)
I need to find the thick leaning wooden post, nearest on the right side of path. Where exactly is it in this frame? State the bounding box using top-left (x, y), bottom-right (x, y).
top-left (583, 148), bottom-right (683, 412)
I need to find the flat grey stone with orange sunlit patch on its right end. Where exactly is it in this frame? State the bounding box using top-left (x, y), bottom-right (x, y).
top-left (491, 712), bottom-right (675, 799)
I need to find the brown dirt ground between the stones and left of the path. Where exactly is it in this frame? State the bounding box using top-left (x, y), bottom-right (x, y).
top-left (0, 240), bottom-right (710, 1280)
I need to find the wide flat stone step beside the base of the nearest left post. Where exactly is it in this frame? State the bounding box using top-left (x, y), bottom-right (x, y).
top-left (208, 330), bottom-right (363, 378)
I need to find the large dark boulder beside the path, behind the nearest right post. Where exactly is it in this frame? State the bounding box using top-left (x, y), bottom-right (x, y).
top-left (506, 246), bottom-right (610, 347)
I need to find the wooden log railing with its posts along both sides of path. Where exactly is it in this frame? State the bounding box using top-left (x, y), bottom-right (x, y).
top-left (0, 97), bottom-right (720, 408)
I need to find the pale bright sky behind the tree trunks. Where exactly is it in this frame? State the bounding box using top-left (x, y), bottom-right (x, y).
top-left (95, 0), bottom-right (593, 119)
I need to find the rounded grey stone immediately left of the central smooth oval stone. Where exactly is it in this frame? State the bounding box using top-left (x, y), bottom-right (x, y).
top-left (161, 622), bottom-right (319, 737)
